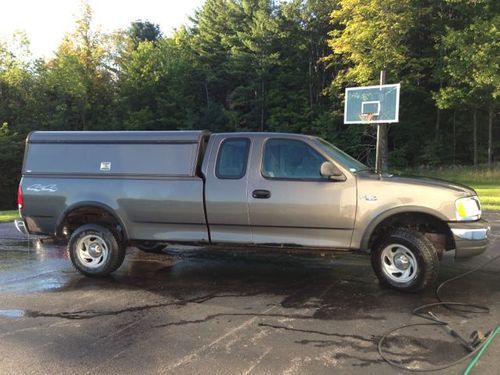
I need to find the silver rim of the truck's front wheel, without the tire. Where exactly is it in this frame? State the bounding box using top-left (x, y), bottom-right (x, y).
top-left (381, 244), bottom-right (418, 283)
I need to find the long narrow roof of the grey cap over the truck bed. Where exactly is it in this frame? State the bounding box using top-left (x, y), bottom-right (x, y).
top-left (26, 130), bottom-right (210, 143)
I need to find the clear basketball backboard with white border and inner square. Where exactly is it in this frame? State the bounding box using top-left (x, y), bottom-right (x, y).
top-left (344, 83), bottom-right (400, 124)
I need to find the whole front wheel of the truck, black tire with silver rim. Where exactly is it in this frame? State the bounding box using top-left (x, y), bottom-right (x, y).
top-left (371, 228), bottom-right (439, 292)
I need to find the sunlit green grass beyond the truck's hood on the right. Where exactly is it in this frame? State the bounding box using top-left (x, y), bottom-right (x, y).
top-left (406, 165), bottom-right (500, 211)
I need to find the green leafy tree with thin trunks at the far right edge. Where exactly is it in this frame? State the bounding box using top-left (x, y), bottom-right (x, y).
top-left (434, 0), bottom-right (500, 165)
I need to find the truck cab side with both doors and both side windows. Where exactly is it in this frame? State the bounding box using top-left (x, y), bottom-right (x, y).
top-left (202, 133), bottom-right (357, 249)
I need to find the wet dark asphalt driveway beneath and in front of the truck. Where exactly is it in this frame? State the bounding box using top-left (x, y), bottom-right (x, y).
top-left (0, 213), bottom-right (500, 374)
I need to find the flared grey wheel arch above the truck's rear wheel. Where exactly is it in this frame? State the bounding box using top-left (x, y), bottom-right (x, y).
top-left (54, 201), bottom-right (129, 241)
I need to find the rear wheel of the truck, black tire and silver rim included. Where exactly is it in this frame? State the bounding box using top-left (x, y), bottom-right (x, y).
top-left (68, 224), bottom-right (125, 277)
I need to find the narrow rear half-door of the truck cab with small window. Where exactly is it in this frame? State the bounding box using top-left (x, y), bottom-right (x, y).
top-left (203, 134), bottom-right (252, 243)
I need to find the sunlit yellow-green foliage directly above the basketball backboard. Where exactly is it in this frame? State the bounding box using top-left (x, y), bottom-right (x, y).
top-left (329, 0), bottom-right (417, 85)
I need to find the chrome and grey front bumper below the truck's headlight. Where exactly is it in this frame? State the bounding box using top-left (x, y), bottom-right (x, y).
top-left (448, 219), bottom-right (491, 258)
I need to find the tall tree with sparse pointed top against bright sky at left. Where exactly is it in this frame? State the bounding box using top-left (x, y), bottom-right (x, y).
top-left (39, 4), bottom-right (113, 130)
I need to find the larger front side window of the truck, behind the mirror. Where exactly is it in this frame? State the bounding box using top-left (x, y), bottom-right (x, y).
top-left (262, 139), bottom-right (325, 180)
